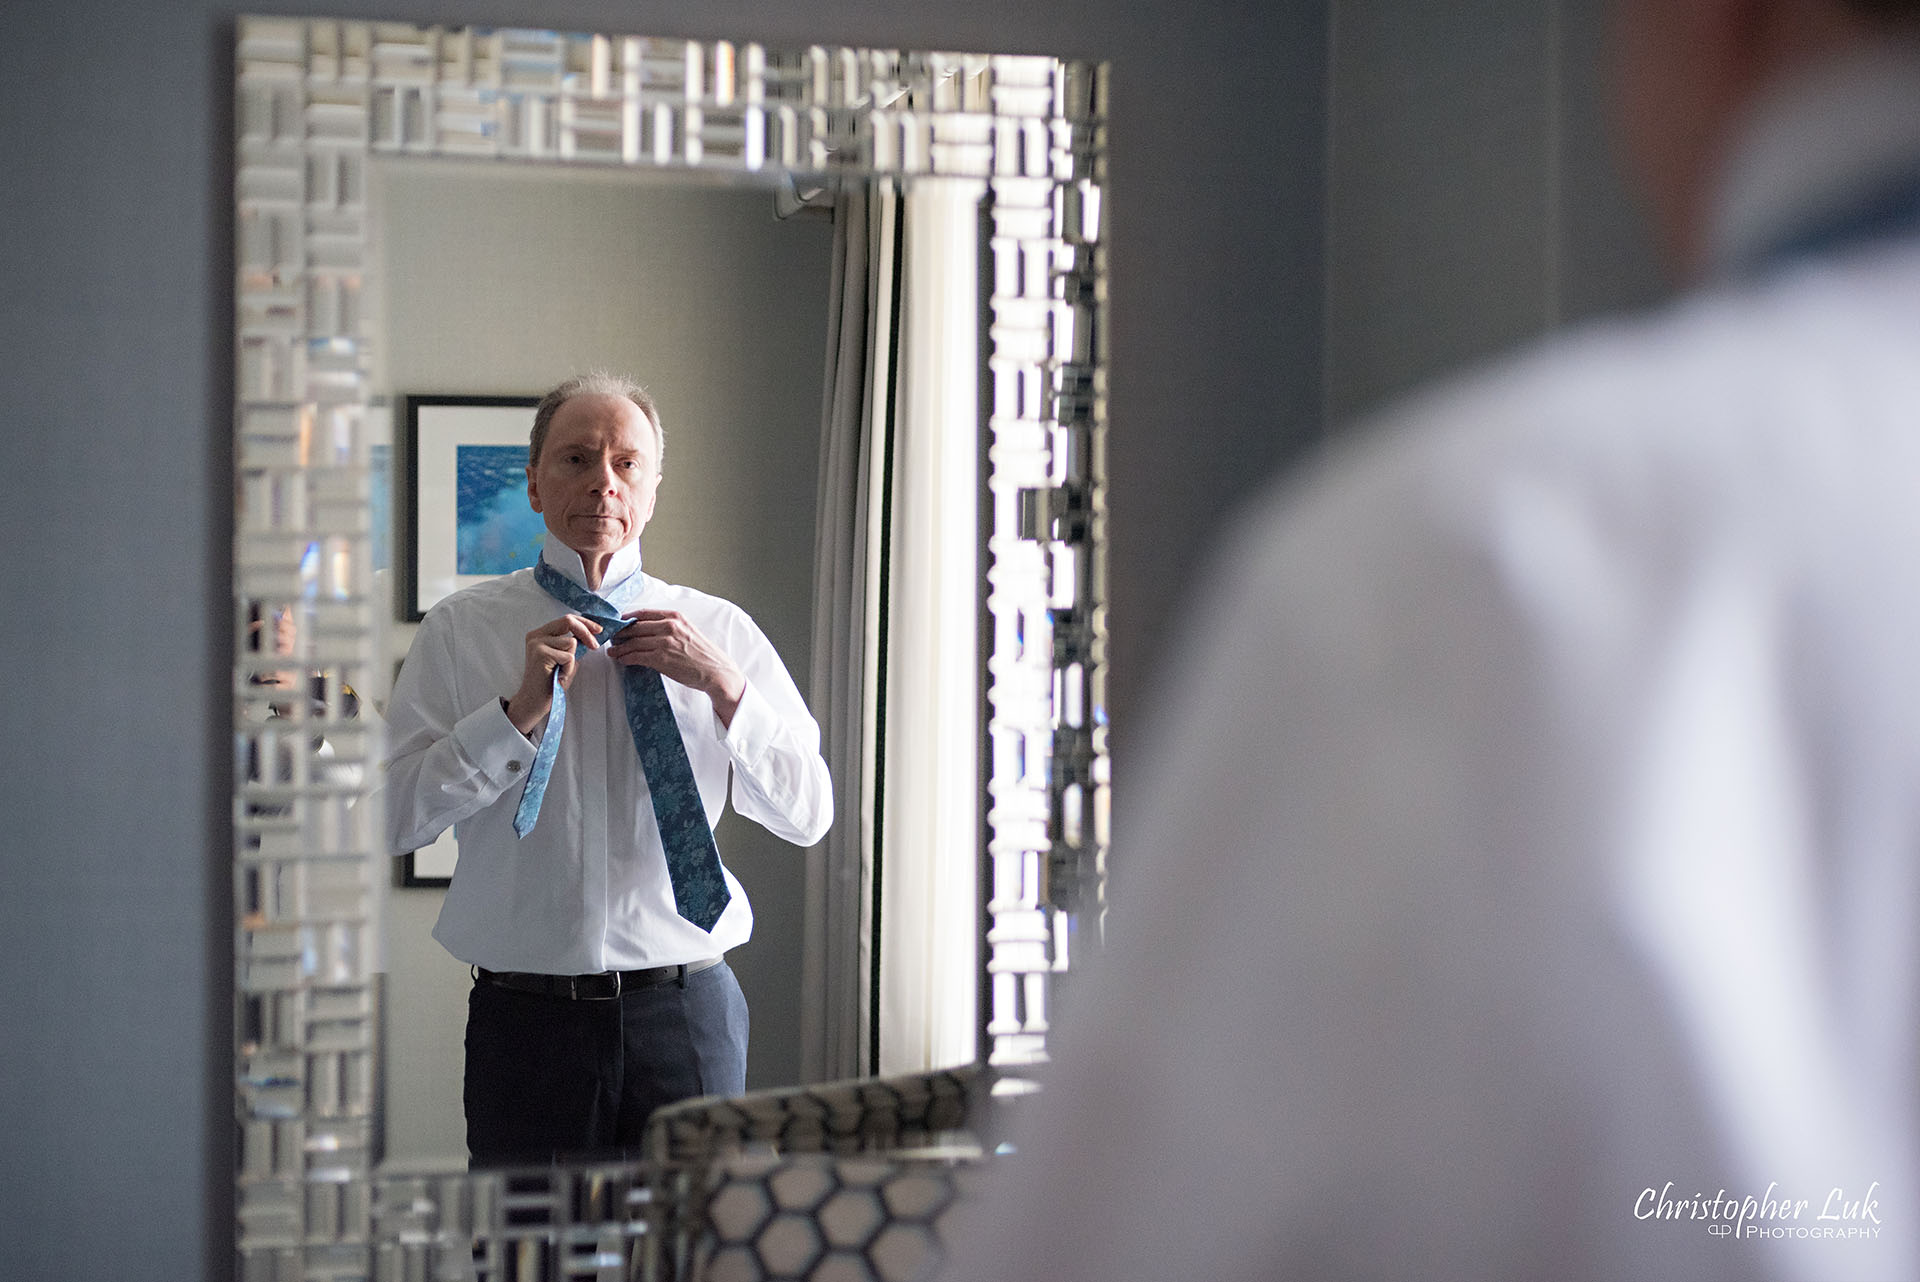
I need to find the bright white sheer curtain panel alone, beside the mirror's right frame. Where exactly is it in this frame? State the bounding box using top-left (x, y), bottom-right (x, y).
top-left (877, 178), bottom-right (983, 1073)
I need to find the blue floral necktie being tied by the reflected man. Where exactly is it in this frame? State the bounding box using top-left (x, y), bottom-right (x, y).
top-left (513, 558), bottom-right (733, 931)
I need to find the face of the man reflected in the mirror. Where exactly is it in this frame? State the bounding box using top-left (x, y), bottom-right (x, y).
top-left (526, 395), bottom-right (660, 560)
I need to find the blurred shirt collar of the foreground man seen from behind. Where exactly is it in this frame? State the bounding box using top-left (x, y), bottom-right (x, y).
top-left (1707, 42), bottom-right (1920, 274)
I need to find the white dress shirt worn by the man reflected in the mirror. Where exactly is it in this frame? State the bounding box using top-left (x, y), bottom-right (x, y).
top-left (384, 535), bottom-right (833, 975)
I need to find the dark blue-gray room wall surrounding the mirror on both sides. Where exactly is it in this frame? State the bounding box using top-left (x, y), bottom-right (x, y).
top-left (0, 0), bottom-right (1657, 1280)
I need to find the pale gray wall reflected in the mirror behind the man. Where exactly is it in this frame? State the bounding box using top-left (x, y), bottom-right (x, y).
top-left (371, 161), bottom-right (833, 1159)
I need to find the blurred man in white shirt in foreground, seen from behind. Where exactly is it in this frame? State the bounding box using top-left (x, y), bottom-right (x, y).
top-left (943, 0), bottom-right (1920, 1282)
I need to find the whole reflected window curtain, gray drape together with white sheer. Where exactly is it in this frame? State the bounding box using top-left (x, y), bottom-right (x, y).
top-left (801, 180), bottom-right (985, 1080)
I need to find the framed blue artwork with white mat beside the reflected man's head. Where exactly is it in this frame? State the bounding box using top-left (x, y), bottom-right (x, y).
top-left (399, 393), bottom-right (547, 622)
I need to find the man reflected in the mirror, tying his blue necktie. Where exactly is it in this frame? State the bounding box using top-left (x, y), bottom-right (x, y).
top-left (386, 374), bottom-right (833, 1165)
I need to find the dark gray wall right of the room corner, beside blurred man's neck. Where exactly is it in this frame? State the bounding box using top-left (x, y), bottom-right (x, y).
top-left (1325, 0), bottom-right (1661, 426)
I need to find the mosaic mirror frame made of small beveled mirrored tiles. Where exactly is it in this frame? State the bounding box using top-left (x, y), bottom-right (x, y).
top-left (234, 17), bottom-right (1110, 1282)
